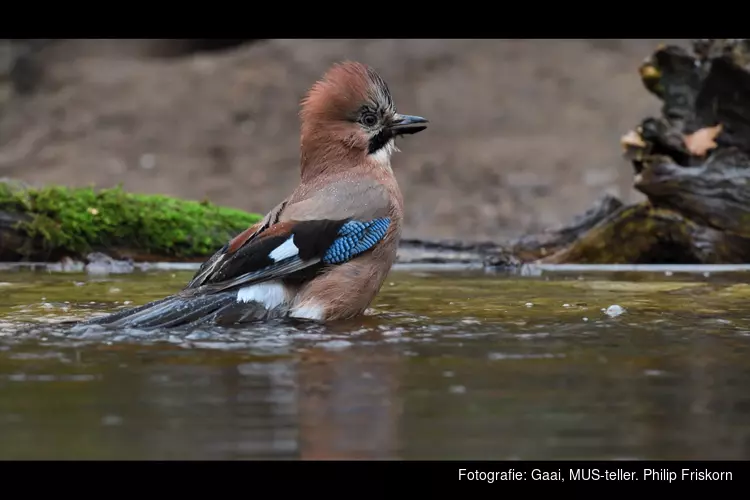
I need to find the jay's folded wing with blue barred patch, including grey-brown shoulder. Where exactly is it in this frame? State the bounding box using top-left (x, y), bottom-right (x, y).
top-left (186, 183), bottom-right (390, 293)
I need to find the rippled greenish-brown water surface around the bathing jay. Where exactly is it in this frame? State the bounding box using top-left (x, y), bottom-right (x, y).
top-left (0, 270), bottom-right (750, 459)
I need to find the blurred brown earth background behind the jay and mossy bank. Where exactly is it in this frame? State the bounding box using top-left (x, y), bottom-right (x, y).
top-left (0, 39), bottom-right (687, 240)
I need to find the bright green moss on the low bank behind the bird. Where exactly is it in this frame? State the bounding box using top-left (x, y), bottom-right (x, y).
top-left (0, 182), bottom-right (262, 258)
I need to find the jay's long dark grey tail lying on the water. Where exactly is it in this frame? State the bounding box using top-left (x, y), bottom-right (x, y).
top-left (74, 291), bottom-right (270, 330)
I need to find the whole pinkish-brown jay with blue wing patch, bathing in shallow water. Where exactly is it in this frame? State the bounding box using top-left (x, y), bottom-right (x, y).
top-left (79, 62), bottom-right (427, 328)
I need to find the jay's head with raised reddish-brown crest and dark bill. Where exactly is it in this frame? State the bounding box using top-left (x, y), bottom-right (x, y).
top-left (300, 62), bottom-right (427, 177)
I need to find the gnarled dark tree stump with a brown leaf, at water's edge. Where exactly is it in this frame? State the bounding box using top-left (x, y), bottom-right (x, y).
top-left (512, 39), bottom-right (750, 264)
